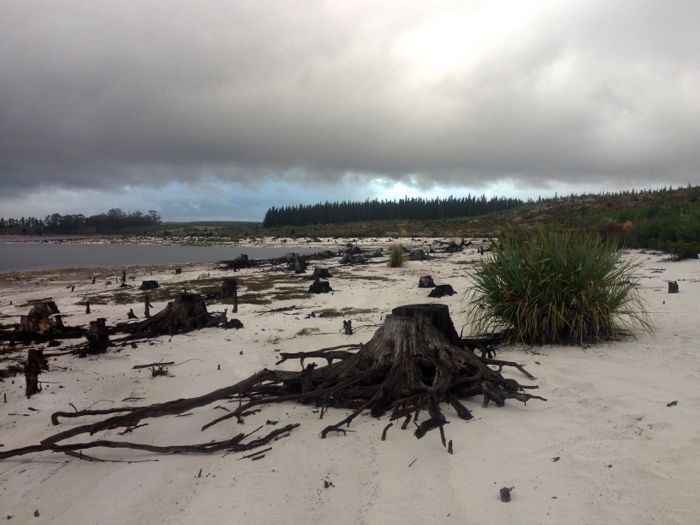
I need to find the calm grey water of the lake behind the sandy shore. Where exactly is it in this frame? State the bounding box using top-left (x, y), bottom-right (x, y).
top-left (0, 239), bottom-right (318, 272)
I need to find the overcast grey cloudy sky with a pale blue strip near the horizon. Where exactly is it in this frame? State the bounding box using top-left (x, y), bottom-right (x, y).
top-left (0, 0), bottom-right (700, 220)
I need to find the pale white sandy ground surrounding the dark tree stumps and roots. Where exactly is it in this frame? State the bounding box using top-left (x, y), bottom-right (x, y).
top-left (0, 240), bottom-right (700, 525)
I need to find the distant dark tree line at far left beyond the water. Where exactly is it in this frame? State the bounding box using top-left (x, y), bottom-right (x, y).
top-left (0, 208), bottom-right (161, 234)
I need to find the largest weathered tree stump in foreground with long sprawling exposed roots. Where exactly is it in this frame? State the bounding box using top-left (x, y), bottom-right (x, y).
top-left (0, 304), bottom-right (544, 459)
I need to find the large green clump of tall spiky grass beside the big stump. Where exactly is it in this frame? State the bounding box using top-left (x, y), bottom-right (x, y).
top-left (468, 228), bottom-right (651, 344)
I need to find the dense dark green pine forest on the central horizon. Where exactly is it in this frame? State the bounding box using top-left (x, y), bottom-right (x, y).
top-left (263, 195), bottom-right (524, 224)
